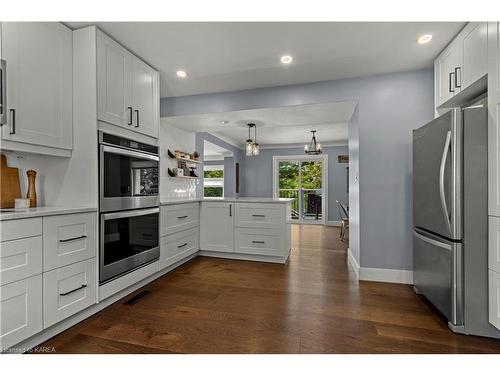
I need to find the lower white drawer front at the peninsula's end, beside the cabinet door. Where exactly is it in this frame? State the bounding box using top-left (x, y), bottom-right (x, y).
top-left (234, 228), bottom-right (284, 256)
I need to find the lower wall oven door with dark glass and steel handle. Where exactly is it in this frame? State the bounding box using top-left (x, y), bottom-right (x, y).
top-left (99, 208), bottom-right (160, 283)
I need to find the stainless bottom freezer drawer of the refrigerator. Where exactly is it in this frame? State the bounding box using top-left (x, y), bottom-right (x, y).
top-left (413, 231), bottom-right (463, 325)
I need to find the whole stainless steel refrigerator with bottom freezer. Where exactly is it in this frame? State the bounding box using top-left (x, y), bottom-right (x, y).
top-left (413, 104), bottom-right (500, 337)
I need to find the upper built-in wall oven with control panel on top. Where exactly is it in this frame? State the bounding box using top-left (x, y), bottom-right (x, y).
top-left (99, 132), bottom-right (160, 212)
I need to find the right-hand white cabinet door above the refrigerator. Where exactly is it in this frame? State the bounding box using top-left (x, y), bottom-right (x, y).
top-left (457, 22), bottom-right (488, 90)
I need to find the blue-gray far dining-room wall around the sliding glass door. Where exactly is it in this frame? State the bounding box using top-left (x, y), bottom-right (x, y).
top-left (241, 146), bottom-right (349, 221)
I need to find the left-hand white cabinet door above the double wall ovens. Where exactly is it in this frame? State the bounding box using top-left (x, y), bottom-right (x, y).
top-left (97, 31), bottom-right (133, 129)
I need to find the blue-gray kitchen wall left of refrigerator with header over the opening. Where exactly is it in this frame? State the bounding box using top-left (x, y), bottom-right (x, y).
top-left (161, 69), bottom-right (434, 270)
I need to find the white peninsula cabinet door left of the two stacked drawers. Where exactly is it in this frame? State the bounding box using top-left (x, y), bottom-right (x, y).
top-left (200, 202), bottom-right (234, 253)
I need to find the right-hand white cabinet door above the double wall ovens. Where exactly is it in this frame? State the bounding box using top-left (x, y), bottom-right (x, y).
top-left (132, 57), bottom-right (160, 138)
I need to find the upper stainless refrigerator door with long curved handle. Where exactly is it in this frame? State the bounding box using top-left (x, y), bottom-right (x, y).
top-left (413, 109), bottom-right (462, 240)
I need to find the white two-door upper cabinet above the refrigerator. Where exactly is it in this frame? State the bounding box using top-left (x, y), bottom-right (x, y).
top-left (434, 22), bottom-right (488, 115)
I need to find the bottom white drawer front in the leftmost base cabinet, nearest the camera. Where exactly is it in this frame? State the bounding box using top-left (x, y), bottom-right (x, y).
top-left (0, 275), bottom-right (42, 349)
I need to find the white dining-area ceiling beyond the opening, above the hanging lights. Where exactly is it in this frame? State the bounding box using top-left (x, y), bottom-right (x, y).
top-left (162, 101), bottom-right (357, 148)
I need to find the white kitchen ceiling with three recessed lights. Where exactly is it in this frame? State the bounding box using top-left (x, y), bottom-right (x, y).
top-left (66, 22), bottom-right (464, 97)
